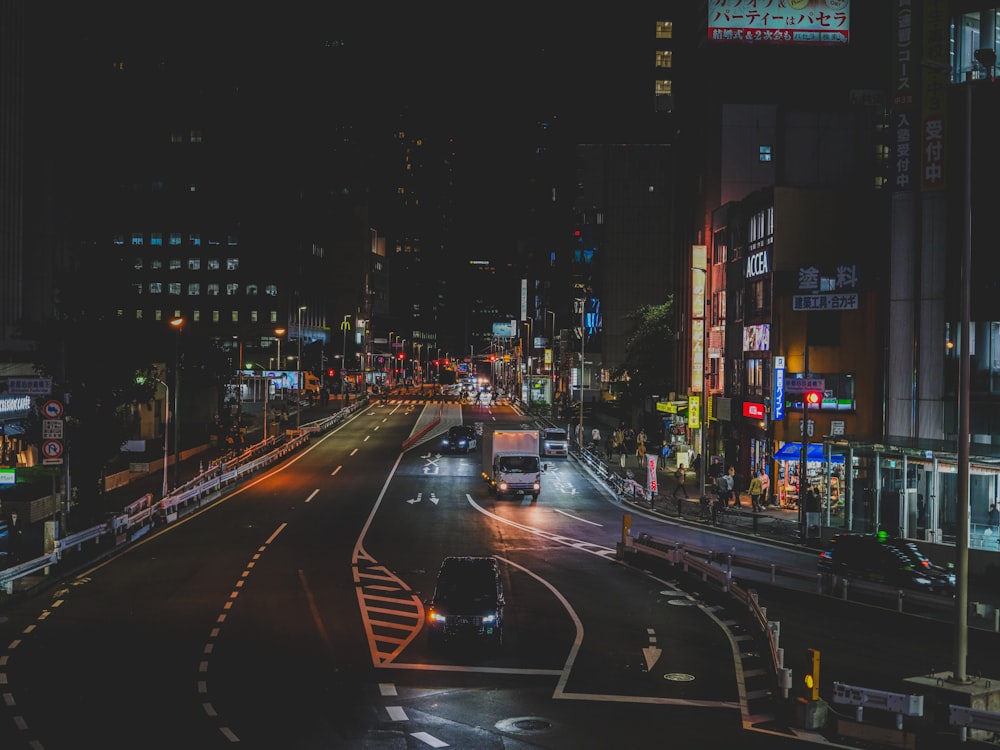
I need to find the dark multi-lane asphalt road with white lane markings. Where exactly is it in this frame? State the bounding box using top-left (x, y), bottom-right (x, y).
top-left (0, 400), bottom-right (997, 750)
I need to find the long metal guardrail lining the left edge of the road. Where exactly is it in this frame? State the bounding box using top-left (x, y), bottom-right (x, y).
top-left (0, 399), bottom-right (367, 595)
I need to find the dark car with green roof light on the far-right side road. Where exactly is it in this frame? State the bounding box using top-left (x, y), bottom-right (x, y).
top-left (816, 534), bottom-right (955, 595)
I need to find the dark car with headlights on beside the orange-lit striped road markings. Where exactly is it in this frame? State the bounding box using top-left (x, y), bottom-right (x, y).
top-left (427, 557), bottom-right (504, 648)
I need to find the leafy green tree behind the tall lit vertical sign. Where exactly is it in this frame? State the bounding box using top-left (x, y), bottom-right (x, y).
top-left (612, 297), bottom-right (675, 400)
